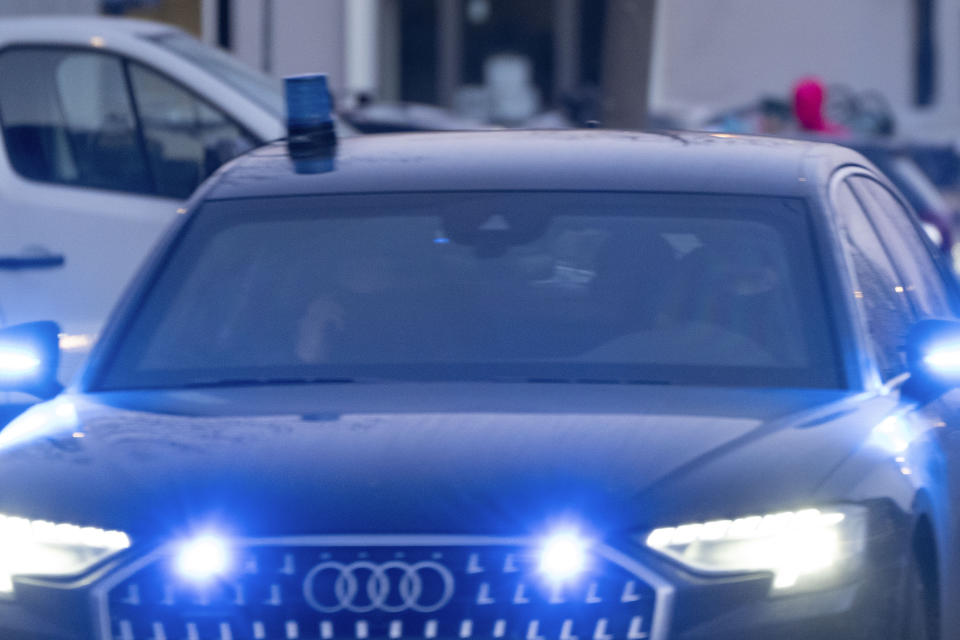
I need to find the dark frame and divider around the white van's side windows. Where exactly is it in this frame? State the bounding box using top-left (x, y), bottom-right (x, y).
top-left (0, 41), bottom-right (267, 201)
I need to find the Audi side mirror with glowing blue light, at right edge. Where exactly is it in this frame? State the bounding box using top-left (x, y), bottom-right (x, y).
top-left (905, 319), bottom-right (960, 397)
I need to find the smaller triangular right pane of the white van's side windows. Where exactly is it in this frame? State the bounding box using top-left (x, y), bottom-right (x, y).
top-left (130, 63), bottom-right (254, 198)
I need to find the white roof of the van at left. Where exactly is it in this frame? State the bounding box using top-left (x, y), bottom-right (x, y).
top-left (0, 16), bottom-right (179, 42)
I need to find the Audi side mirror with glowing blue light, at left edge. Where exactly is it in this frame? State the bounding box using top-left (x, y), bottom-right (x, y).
top-left (0, 322), bottom-right (63, 400)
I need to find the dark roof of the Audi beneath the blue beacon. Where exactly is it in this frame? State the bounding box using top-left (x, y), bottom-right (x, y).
top-left (200, 129), bottom-right (869, 200)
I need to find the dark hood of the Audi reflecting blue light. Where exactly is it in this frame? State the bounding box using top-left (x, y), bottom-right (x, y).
top-left (0, 384), bottom-right (868, 536)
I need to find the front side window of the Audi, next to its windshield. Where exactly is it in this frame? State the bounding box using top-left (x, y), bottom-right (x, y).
top-left (834, 183), bottom-right (914, 380)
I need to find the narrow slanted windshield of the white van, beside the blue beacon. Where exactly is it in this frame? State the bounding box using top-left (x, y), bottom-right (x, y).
top-left (149, 33), bottom-right (284, 119)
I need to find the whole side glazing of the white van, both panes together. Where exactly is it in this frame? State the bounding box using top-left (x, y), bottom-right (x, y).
top-left (0, 47), bottom-right (257, 199)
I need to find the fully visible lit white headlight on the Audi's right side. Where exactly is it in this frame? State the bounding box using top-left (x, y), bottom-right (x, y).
top-left (644, 506), bottom-right (866, 590)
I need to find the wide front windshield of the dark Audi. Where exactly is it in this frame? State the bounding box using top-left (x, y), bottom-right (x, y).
top-left (98, 192), bottom-right (839, 389)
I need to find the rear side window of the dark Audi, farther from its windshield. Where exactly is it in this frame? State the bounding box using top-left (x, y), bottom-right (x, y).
top-left (850, 177), bottom-right (950, 317)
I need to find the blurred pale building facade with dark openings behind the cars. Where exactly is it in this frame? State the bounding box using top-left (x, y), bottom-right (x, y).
top-left (0, 0), bottom-right (960, 136)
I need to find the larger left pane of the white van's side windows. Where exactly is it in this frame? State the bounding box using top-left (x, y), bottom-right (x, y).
top-left (0, 47), bottom-right (153, 193)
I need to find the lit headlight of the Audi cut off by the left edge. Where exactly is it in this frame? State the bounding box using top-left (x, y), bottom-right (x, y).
top-left (0, 514), bottom-right (130, 595)
